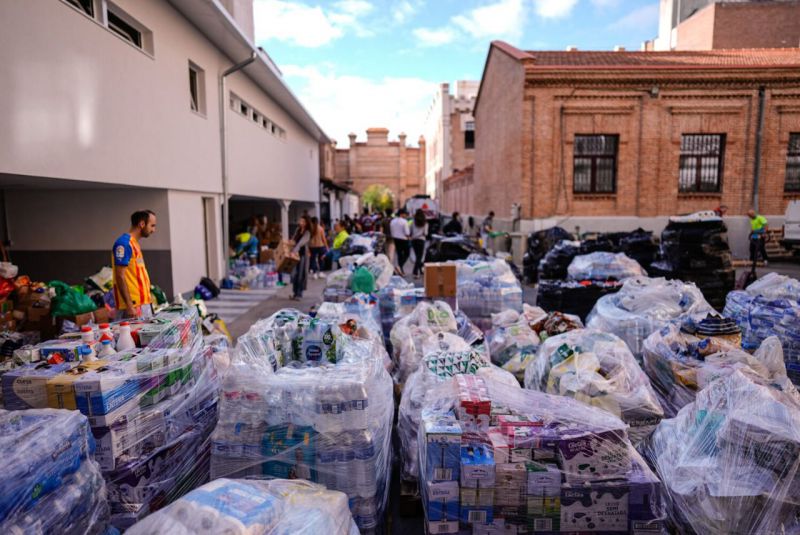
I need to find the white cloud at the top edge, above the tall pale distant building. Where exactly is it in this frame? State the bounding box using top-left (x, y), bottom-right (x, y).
top-left (451, 0), bottom-right (528, 40)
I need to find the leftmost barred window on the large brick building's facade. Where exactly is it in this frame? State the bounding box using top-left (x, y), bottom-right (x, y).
top-left (572, 134), bottom-right (619, 193)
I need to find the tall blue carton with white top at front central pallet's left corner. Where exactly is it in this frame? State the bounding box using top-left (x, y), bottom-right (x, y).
top-left (422, 413), bottom-right (462, 481)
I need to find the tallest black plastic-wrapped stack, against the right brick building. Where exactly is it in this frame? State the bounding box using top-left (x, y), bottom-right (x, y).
top-left (650, 212), bottom-right (736, 310)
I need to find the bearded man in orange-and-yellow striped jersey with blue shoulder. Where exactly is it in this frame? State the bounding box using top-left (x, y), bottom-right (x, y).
top-left (112, 210), bottom-right (156, 318)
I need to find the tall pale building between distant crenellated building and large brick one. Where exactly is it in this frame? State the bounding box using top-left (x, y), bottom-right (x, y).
top-left (424, 80), bottom-right (480, 199)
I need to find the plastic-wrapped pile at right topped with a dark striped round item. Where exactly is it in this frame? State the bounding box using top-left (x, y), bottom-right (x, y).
top-left (643, 324), bottom-right (795, 418)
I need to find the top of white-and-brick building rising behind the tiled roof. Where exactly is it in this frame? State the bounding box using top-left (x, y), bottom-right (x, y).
top-left (644, 0), bottom-right (800, 51)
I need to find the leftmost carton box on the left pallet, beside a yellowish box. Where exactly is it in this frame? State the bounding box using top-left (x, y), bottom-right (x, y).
top-left (2, 362), bottom-right (72, 410)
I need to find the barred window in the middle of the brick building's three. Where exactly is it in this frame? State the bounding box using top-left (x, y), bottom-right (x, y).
top-left (678, 134), bottom-right (725, 193)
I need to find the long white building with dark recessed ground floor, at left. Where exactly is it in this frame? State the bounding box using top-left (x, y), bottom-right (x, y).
top-left (0, 0), bottom-right (328, 294)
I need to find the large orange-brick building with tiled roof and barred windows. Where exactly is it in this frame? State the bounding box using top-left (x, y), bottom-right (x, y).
top-left (474, 41), bottom-right (800, 254)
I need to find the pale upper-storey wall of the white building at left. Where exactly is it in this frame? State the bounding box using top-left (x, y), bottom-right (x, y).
top-left (0, 0), bottom-right (319, 201)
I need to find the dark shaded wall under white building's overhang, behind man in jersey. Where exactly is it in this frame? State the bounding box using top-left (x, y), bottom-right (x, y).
top-left (5, 189), bottom-right (175, 295)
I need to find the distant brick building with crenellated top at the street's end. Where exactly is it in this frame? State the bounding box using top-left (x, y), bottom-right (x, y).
top-left (334, 128), bottom-right (425, 206)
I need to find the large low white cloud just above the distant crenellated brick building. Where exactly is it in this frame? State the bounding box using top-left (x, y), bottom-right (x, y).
top-left (281, 65), bottom-right (436, 148)
